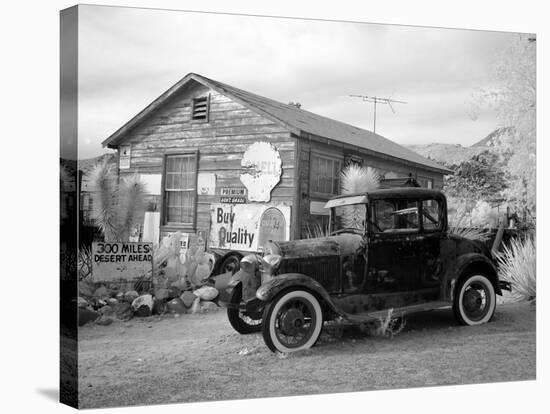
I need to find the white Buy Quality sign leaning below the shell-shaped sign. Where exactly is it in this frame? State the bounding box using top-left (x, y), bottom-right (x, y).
top-left (208, 204), bottom-right (290, 252)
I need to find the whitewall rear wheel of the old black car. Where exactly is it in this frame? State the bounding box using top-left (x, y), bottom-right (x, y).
top-left (453, 273), bottom-right (496, 325)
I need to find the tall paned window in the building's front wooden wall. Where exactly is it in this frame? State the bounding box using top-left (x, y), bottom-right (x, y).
top-left (164, 153), bottom-right (197, 226)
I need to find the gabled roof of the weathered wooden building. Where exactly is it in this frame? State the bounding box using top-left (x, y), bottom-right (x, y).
top-left (103, 73), bottom-right (452, 174)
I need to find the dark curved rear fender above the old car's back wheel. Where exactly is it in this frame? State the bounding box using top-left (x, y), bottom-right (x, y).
top-left (441, 253), bottom-right (502, 301)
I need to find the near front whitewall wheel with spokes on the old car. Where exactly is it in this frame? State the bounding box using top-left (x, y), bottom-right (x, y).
top-left (262, 290), bottom-right (323, 353)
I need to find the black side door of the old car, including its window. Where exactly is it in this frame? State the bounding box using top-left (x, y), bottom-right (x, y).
top-left (366, 198), bottom-right (423, 293)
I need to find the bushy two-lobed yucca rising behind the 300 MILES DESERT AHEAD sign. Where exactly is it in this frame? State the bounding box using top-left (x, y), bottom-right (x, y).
top-left (90, 162), bottom-right (145, 241)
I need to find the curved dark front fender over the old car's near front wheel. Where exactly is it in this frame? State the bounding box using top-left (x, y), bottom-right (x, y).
top-left (256, 273), bottom-right (344, 316)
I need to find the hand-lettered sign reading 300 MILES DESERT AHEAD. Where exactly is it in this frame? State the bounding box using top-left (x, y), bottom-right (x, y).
top-left (92, 242), bottom-right (153, 281)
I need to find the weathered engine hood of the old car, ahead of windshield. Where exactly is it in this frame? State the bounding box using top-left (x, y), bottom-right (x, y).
top-left (272, 233), bottom-right (362, 258)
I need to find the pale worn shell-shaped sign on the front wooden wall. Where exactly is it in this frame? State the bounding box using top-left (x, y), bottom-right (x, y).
top-left (240, 141), bottom-right (282, 202)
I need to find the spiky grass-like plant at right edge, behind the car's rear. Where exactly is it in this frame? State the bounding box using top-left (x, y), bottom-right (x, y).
top-left (497, 236), bottom-right (537, 301)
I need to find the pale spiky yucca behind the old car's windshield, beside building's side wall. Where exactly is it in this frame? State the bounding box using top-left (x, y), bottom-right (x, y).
top-left (342, 164), bottom-right (380, 229)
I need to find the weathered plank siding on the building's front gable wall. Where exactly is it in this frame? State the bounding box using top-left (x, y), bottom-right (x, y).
top-left (120, 82), bottom-right (296, 246)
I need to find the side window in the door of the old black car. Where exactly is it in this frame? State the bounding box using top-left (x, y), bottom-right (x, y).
top-left (373, 200), bottom-right (419, 233)
